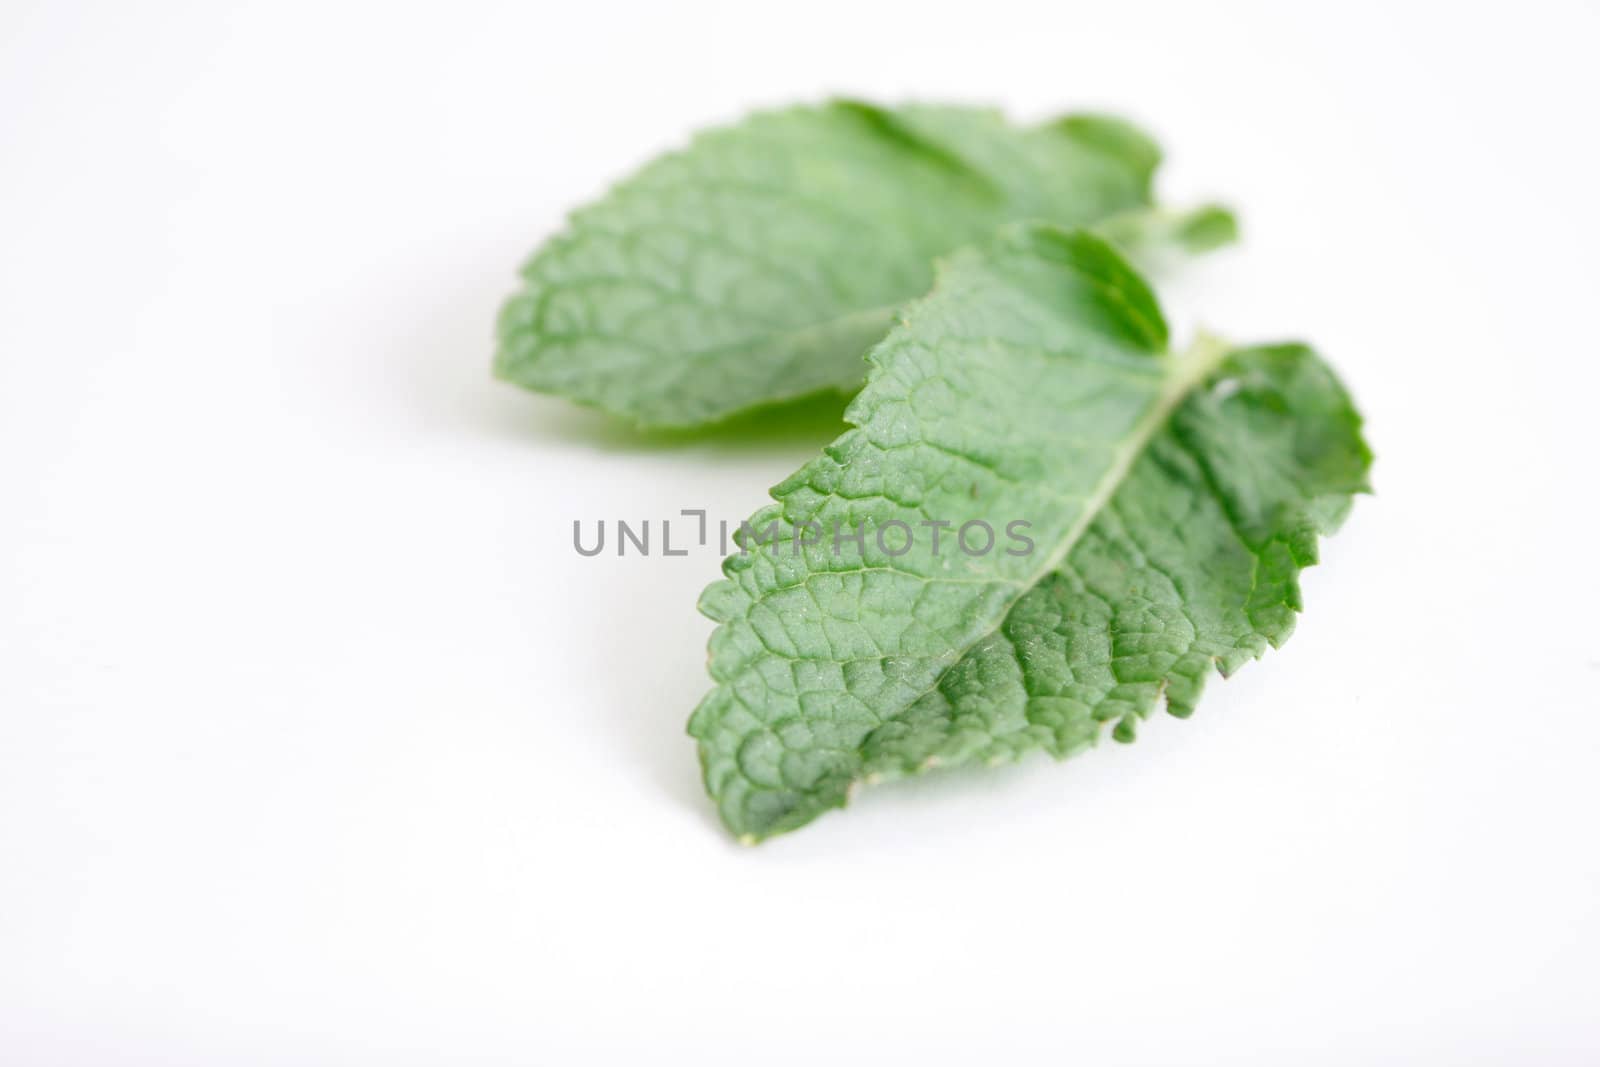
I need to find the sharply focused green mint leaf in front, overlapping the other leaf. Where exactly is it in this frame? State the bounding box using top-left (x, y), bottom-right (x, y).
top-left (690, 227), bottom-right (1370, 841)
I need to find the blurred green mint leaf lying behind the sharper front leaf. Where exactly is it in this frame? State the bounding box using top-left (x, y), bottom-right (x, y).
top-left (494, 101), bottom-right (1230, 427)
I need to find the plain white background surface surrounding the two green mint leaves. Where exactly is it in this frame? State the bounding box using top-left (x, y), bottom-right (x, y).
top-left (0, 2), bottom-right (1600, 1067)
